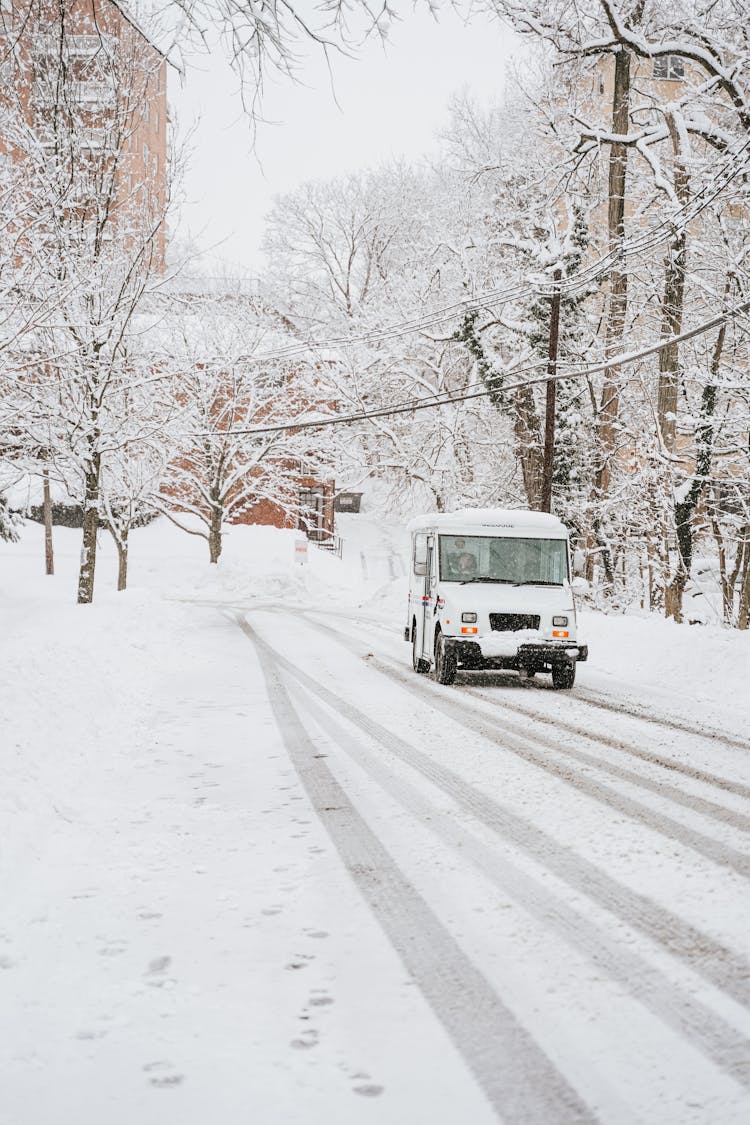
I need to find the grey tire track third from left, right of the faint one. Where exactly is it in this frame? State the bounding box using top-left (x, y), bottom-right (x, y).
top-left (246, 616), bottom-right (750, 1007)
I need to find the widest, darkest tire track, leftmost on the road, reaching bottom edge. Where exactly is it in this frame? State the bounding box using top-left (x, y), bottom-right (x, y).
top-left (235, 617), bottom-right (597, 1125)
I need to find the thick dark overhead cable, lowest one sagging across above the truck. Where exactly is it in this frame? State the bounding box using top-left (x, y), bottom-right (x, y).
top-left (212, 300), bottom-right (750, 437)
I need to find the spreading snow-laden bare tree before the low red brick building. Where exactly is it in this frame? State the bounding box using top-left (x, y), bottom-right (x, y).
top-left (159, 297), bottom-right (326, 563)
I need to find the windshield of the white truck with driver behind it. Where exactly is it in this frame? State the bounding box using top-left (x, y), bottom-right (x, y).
top-left (440, 536), bottom-right (568, 586)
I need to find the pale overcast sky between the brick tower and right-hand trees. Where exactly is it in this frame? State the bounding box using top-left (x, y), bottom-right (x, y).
top-left (172, 9), bottom-right (519, 273)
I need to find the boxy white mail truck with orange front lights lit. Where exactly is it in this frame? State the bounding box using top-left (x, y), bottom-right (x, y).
top-left (404, 509), bottom-right (588, 687)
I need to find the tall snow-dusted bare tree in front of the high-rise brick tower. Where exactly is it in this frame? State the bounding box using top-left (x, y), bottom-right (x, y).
top-left (3, 0), bottom-right (168, 602)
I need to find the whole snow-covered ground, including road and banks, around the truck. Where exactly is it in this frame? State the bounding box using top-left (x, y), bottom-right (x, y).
top-left (0, 516), bottom-right (750, 1125)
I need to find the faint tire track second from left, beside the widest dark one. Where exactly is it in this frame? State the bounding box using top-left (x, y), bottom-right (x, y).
top-left (297, 687), bottom-right (750, 1089)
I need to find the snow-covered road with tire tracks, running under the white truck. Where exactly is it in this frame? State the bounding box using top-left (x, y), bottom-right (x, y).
top-left (227, 612), bottom-right (750, 1123)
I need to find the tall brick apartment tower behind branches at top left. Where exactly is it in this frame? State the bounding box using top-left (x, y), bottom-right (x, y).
top-left (0, 0), bottom-right (168, 269)
